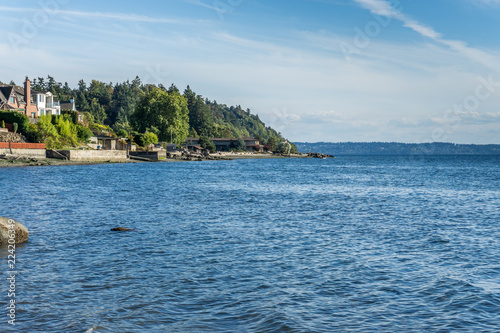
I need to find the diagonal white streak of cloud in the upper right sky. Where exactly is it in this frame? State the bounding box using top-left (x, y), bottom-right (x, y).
top-left (354, 0), bottom-right (500, 71)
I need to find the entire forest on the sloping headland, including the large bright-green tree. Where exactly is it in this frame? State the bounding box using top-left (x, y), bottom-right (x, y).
top-left (17, 75), bottom-right (295, 150)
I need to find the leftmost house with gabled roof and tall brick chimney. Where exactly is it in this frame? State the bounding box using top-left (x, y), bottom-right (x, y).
top-left (0, 78), bottom-right (38, 118)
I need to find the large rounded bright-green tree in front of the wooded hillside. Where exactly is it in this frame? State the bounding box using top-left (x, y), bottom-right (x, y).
top-left (131, 87), bottom-right (189, 144)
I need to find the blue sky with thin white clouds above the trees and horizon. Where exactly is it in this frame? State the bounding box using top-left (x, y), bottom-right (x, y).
top-left (0, 0), bottom-right (500, 144)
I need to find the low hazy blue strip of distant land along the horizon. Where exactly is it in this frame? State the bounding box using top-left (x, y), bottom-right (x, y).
top-left (295, 142), bottom-right (500, 156)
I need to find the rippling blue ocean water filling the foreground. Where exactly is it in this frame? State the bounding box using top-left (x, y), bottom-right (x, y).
top-left (0, 156), bottom-right (500, 332)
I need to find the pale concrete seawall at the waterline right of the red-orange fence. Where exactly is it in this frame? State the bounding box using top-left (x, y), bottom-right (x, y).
top-left (47, 150), bottom-right (128, 162)
